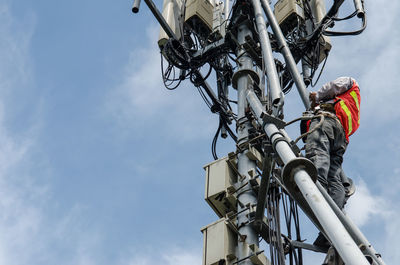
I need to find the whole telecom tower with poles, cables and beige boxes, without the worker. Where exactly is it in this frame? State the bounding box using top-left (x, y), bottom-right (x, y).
top-left (132, 0), bottom-right (385, 265)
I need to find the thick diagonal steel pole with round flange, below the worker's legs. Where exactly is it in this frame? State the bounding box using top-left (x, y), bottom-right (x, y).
top-left (246, 89), bottom-right (369, 265)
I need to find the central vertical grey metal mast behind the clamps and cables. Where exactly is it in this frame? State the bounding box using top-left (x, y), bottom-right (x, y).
top-left (236, 24), bottom-right (258, 265)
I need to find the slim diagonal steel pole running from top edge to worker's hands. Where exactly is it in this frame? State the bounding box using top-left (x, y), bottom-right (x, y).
top-left (260, 0), bottom-right (310, 110)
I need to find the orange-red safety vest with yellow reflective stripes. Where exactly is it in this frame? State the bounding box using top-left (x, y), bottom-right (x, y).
top-left (335, 80), bottom-right (361, 141)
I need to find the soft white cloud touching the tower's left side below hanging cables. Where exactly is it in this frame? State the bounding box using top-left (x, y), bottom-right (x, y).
top-left (107, 26), bottom-right (218, 141)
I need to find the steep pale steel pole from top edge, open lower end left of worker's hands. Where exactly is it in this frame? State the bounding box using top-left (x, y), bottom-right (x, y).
top-left (252, 0), bottom-right (282, 107)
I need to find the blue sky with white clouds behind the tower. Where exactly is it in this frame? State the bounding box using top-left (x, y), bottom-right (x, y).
top-left (0, 0), bottom-right (400, 265)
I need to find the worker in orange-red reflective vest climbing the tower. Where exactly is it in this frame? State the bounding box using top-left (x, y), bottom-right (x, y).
top-left (306, 77), bottom-right (361, 247)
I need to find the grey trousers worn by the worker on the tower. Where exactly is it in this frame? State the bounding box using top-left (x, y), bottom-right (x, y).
top-left (306, 117), bottom-right (347, 209)
